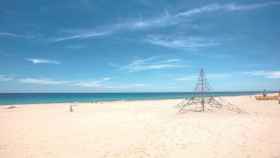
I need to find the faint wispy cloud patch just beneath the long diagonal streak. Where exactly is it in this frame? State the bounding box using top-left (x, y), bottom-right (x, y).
top-left (144, 36), bottom-right (220, 50)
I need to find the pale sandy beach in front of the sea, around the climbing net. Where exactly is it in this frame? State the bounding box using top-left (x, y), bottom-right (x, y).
top-left (0, 95), bottom-right (280, 158)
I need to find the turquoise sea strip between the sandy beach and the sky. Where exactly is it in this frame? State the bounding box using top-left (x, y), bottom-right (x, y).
top-left (0, 92), bottom-right (260, 105)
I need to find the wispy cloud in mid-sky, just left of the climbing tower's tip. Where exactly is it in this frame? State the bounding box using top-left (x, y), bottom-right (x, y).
top-left (121, 57), bottom-right (187, 72)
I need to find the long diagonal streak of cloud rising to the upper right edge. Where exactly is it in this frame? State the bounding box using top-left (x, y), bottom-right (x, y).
top-left (50, 1), bottom-right (280, 42)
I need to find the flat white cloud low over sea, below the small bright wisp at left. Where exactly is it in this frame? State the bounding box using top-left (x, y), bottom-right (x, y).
top-left (18, 78), bottom-right (70, 85)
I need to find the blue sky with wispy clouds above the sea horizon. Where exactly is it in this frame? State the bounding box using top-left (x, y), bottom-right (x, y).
top-left (0, 0), bottom-right (280, 92)
